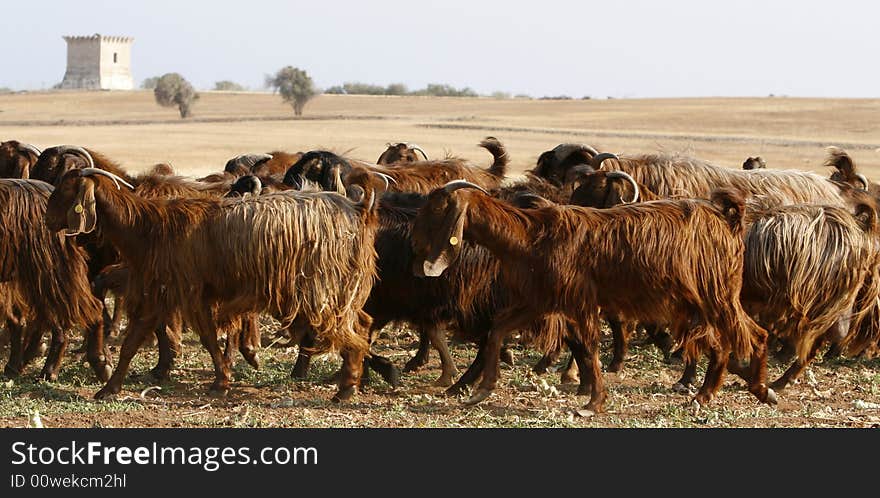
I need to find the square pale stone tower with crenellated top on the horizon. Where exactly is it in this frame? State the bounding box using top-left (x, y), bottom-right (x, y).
top-left (61, 34), bottom-right (134, 90)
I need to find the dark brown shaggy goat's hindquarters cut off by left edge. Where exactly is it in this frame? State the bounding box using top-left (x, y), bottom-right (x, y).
top-left (0, 180), bottom-right (110, 380)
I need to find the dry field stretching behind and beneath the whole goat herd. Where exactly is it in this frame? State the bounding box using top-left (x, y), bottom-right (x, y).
top-left (0, 92), bottom-right (880, 427)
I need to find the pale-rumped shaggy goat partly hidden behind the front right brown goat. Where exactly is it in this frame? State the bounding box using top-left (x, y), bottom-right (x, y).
top-left (572, 171), bottom-right (880, 390)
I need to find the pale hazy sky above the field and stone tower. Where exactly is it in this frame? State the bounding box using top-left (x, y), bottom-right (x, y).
top-left (0, 0), bottom-right (880, 97)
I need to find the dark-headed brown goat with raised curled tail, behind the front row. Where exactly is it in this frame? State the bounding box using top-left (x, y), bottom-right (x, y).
top-left (284, 137), bottom-right (509, 193)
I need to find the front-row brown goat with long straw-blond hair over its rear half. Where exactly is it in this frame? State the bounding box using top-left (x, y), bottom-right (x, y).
top-left (46, 168), bottom-right (376, 400)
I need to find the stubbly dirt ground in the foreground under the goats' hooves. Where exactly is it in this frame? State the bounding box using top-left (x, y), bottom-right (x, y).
top-left (0, 321), bottom-right (880, 428)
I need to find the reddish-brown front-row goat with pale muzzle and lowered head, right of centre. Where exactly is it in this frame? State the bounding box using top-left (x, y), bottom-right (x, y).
top-left (413, 182), bottom-right (776, 411)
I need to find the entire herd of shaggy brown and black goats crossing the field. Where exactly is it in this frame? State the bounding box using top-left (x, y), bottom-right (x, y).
top-left (0, 137), bottom-right (880, 412)
